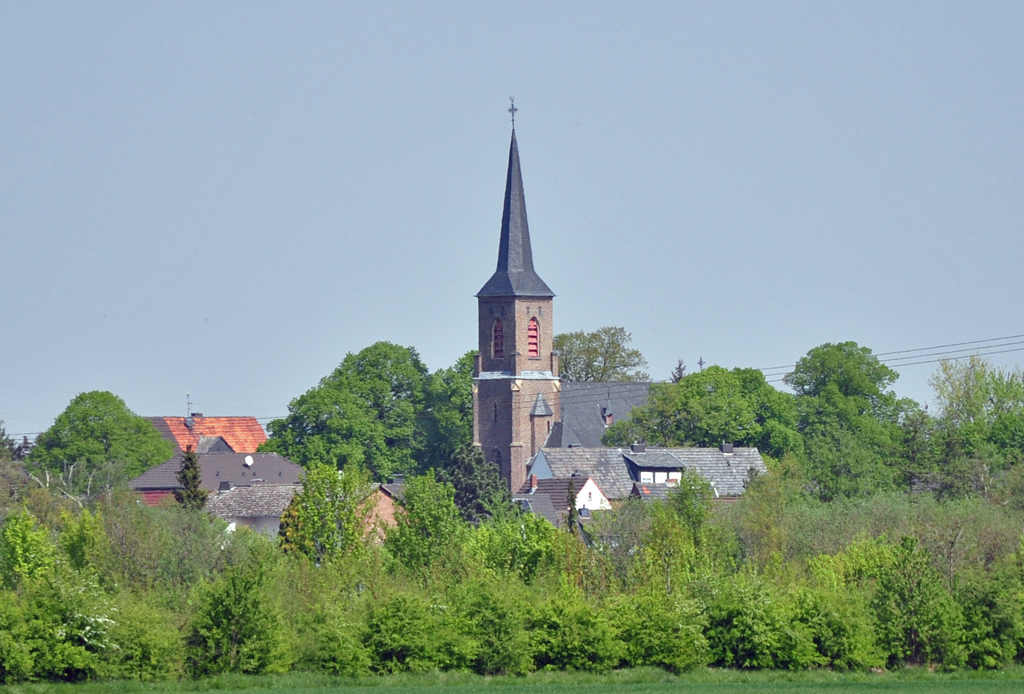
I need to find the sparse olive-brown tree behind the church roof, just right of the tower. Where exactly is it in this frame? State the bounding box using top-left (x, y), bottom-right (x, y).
top-left (553, 326), bottom-right (650, 382)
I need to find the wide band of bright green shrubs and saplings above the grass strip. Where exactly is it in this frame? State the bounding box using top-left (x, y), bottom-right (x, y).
top-left (0, 458), bottom-right (1024, 683)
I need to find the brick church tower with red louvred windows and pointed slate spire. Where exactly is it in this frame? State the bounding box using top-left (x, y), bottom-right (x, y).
top-left (473, 126), bottom-right (561, 492)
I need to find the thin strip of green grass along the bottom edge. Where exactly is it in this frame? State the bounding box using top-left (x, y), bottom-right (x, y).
top-left (6, 667), bottom-right (1024, 694)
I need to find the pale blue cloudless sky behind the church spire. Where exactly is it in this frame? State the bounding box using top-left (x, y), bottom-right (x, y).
top-left (0, 2), bottom-right (1024, 433)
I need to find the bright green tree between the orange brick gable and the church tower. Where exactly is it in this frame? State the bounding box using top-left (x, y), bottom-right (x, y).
top-left (384, 470), bottom-right (467, 572)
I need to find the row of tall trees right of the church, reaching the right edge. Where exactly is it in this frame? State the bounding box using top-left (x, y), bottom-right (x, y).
top-left (605, 342), bottom-right (1024, 503)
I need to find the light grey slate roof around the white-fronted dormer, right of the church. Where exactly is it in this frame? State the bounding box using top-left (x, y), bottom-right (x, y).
top-left (623, 446), bottom-right (768, 496)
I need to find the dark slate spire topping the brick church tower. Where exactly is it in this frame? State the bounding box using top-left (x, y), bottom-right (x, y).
top-left (476, 128), bottom-right (555, 297)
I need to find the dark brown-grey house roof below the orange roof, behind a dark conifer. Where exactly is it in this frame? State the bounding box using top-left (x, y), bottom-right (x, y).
top-left (128, 453), bottom-right (302, 491)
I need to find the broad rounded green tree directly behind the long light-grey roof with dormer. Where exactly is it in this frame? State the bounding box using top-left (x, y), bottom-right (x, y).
top-left (604, 366), bottom-right (802, 457)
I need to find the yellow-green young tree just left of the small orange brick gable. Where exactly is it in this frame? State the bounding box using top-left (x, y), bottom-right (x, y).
top-left (279, 463), bottom-right (370, 563)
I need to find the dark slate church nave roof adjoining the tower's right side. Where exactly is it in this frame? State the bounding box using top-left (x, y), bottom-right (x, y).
top-left (544, 382), bottom-right (650, 448)
